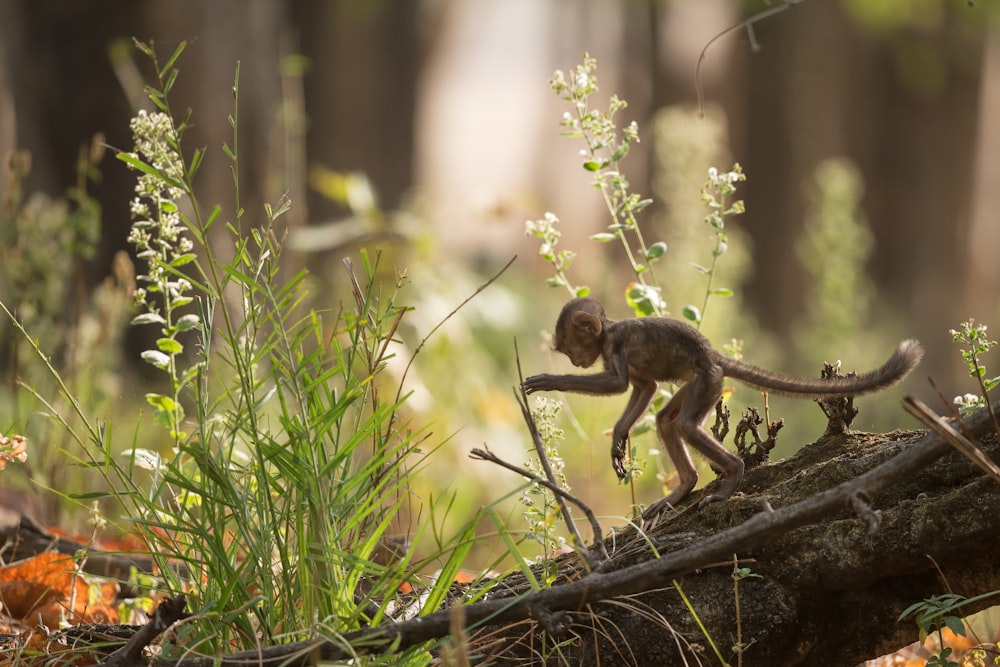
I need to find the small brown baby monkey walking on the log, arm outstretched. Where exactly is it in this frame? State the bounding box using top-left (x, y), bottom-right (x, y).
top-left (524, 297), bottom-right (924, 519)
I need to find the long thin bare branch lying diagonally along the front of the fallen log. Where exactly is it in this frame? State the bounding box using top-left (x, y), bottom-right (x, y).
top-left (154, 401), bottom-right (1000, 667)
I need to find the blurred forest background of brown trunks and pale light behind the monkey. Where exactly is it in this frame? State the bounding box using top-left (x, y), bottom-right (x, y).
top-left (0, 0), bottom-right (1000, 540)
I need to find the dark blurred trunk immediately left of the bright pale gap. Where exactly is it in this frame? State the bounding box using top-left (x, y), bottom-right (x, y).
top-left (290, 0), bottom-right (421, 219)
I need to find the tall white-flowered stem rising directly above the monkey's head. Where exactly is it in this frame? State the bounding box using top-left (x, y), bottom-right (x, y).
top-left (549, 54), bottom-right (667, 316)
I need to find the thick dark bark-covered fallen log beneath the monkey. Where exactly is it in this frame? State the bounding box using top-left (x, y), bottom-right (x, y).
top-left (473, 431), bottom-right (1000, 667)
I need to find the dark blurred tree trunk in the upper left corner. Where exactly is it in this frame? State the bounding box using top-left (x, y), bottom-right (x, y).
top-left (0, 0), bottom-right (141, 290)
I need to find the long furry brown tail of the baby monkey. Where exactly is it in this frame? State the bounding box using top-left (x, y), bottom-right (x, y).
top-left (719, 339), bottom-right (924, 398)
